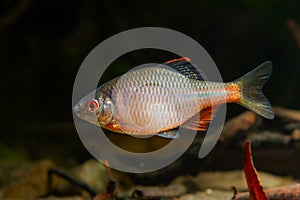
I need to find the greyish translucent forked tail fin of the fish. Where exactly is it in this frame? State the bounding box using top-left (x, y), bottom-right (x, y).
top-left (236, 61), bottom-right (274, 119)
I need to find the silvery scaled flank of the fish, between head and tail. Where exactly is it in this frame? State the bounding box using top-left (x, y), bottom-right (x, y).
top-left (106, 68), bottom-right (226, 134)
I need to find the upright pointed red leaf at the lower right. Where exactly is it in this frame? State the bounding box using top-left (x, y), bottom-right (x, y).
top-left (244, 141), bottom-right (267, 200)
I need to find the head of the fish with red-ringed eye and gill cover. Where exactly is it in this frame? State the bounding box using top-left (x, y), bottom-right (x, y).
top-left (73, 93), bottom-right (114, 127)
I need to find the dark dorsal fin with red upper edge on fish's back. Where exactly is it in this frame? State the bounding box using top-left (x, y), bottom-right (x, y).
top-left (164, 57), bottom-right (204, 80)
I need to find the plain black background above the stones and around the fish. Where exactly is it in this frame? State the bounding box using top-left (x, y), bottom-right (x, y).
top-left (0, 0), bottom-right (300, 165)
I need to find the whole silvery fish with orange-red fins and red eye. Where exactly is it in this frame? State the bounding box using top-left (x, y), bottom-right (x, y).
top-left (73, 57), bottom-right (274, 138)
